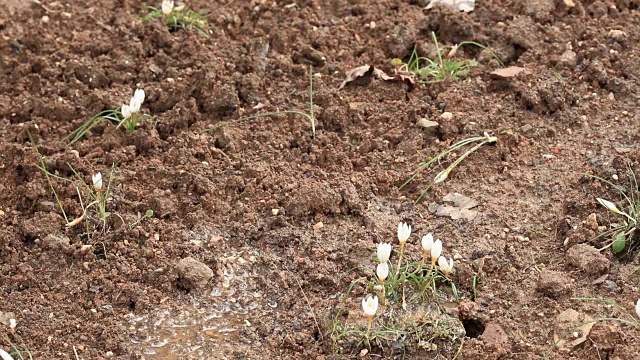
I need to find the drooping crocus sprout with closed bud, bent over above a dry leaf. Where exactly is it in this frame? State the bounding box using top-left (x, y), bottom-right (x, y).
top-left (400, 132), bottom-right (498, 202)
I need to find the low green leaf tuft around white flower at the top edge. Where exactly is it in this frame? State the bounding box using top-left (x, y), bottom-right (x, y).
top-left (142, 0), bottom-right (209, 36)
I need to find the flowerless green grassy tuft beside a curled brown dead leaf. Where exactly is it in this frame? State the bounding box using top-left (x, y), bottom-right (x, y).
top-left (392, 32), bottom-right (502, 84)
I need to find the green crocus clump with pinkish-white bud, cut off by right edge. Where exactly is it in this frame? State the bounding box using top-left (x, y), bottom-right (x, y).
top-left (586, 168), bottom-right (640, 254)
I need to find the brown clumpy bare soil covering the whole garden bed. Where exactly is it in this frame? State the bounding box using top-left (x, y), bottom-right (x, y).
top-left (0, 0), bottom-right (640, 359)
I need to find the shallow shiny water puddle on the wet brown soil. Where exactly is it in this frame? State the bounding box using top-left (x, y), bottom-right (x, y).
top-left (128, 248), bottom-right (277, 360)
